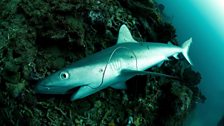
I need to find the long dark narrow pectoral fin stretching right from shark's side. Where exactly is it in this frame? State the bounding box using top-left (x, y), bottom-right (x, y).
top-left (121, 69), bottom-right (180, 80)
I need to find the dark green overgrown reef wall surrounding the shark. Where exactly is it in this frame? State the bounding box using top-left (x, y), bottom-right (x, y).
top-left (0, 0), bottom-right (206, 126)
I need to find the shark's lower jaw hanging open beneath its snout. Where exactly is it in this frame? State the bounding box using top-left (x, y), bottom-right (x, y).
top-left (71, 86), bottom-right (98, 101)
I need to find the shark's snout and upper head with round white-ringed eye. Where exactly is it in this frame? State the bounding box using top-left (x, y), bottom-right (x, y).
top-left (35, 69), bottom-right (86, 94)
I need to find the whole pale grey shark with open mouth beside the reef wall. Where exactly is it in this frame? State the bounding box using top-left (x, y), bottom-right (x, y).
top-left (36, 25), bottom-right (192, 100)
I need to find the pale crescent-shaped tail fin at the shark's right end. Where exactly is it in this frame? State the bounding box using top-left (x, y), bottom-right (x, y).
top-left (182, 38), bottom-right (193, 65)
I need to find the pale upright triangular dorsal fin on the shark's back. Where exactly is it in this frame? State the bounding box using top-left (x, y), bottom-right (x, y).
top-left (117, 24), bottom-right (137, 44)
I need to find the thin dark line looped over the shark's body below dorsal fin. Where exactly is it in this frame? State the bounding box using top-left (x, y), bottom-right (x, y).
top-left (88, 46), bottom-right (138, 89)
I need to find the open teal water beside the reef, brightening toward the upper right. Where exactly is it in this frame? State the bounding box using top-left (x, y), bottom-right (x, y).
top-left (159, 0), bottom-right (224, 126)
